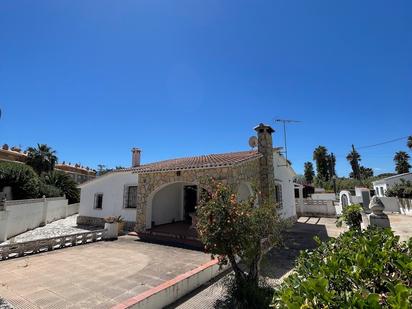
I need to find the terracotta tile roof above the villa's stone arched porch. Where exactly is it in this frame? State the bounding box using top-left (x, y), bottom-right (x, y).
top-left (117, 150), bottom-right (262, 174)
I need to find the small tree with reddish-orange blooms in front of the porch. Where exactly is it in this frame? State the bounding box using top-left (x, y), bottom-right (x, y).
top-left (197, 181), bottom-right (283, 308)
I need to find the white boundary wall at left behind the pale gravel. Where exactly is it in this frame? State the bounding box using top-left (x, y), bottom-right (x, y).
top-left (0, 197), bottom-right (79, 242)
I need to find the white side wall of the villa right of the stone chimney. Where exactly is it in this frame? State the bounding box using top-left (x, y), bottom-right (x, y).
top-left (273, 152), bottom-right (296, 218)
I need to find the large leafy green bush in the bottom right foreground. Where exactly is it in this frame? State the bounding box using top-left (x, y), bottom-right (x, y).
top-left (272, 228), bottom-right (412, 309)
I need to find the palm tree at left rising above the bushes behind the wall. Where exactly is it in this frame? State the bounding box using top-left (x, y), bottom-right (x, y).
top-left (26, 144), bottom-right (57, 175)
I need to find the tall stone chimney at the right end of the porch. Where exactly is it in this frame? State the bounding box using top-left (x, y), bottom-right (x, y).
top-left (254, 123), bottom-right (276, 204)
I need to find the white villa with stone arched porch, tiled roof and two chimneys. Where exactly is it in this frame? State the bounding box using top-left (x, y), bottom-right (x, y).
top-left (78, 124), bottom-right (296, 231)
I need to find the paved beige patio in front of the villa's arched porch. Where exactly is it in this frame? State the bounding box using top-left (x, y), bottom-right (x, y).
top-left (0, 236), bottom-right (210, 308)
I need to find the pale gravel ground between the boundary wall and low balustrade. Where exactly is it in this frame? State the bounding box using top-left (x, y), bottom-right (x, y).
top-left (0, 215), bottom-right (98, 245)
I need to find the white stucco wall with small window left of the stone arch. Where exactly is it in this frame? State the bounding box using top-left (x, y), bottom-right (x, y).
top-left (79, 172), bottom-right (138, 222)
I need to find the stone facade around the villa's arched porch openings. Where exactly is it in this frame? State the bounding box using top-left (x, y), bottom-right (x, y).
top-left (136, 159), bottom-right (259, 231)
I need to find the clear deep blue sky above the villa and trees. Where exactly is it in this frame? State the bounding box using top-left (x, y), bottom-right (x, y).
top-left (0, 0), bottom-right (412, 176)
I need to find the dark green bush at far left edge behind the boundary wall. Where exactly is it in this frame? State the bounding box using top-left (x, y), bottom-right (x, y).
top-left (0, 162), bottom-right (39, 199)
